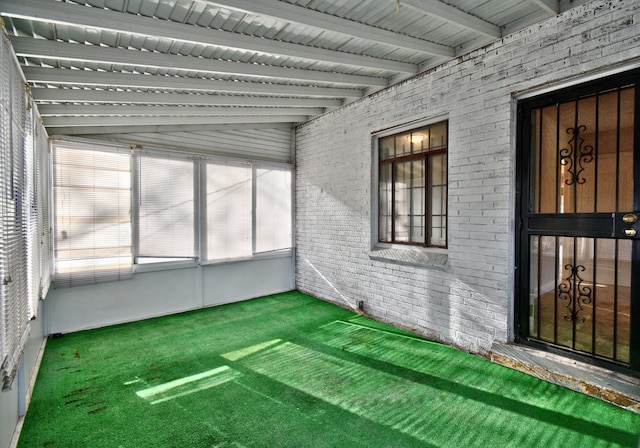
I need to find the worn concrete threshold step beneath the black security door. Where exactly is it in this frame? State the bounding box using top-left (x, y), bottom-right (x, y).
top-left (489, 344), bottom-right (640, 413)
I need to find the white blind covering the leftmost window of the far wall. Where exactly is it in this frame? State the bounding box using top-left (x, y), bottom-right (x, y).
top-left (53, 142), bottom-right (132, 287)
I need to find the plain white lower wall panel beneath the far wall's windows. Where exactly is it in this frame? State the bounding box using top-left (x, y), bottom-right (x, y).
top-left (45, 256), bottom-right (294, 334)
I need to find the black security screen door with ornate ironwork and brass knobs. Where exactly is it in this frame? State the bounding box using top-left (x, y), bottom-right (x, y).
top-left (516, 70), bottom-right (640, 372)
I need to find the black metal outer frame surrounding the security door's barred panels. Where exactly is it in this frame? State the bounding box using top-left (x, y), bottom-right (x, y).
top-left (514, 69), bottom-right (640, 377)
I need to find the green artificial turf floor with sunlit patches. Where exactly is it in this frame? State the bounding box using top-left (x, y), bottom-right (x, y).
top-left (18, 292), bottom-right (640, 448)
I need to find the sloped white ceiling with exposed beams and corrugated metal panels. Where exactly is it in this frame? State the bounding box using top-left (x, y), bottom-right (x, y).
top-left (0, 0), bottom-right (584, 150)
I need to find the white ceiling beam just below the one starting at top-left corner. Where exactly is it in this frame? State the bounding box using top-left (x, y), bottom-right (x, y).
top-left (11, 37), bottom-right (389, 87)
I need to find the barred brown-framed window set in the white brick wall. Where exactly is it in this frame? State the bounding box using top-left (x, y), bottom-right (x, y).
top-left (378, 121), bottom-right (448, 248)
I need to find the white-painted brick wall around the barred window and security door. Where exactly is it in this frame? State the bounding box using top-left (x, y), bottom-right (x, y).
top-left (296, 0), bottom-right (640, 352)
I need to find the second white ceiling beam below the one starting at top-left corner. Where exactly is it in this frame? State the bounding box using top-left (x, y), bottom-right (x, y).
top-left (22, 66), bottom-right (363, 98)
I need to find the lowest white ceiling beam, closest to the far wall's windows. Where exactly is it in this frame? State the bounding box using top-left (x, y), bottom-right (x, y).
top-left (42, 115), bottom-right (309, 128)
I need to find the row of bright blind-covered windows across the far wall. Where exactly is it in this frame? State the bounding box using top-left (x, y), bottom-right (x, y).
top-left (54, 142), bottom-right (292, 274)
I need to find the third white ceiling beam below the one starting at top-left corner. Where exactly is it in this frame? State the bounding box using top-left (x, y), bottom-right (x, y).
top-left (31, 87), bottom-right (342, 107)
